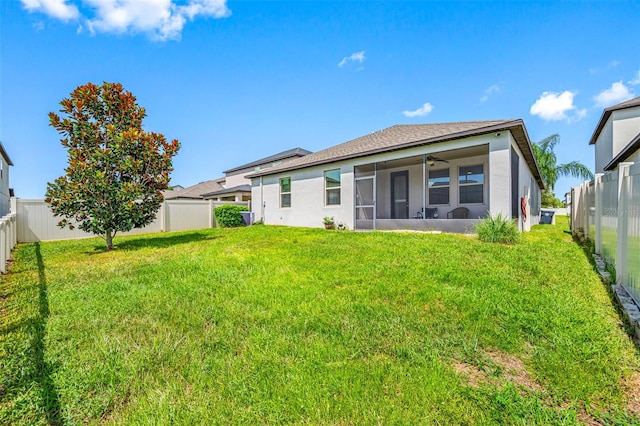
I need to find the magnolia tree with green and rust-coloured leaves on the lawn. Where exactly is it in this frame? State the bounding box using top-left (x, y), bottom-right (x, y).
top-left (46, 83), bottom-right (180, 250)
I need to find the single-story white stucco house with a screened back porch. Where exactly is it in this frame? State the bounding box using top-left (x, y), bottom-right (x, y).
top-left (249, 120), bottom-right (544, 232)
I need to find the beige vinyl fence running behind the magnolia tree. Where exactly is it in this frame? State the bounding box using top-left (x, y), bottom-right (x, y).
top-left (12, 199), bottom-right (247, 243)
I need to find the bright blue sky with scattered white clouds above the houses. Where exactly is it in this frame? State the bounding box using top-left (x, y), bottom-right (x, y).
top-left (0, 0), bottom-right (640, 198)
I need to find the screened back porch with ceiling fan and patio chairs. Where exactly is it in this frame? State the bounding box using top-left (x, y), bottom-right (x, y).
top-left (354, 145), bottom-right (489, 233)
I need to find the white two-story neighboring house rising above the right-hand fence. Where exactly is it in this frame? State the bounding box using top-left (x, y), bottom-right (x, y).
top-left (589, 97), bottom-right (640, 173)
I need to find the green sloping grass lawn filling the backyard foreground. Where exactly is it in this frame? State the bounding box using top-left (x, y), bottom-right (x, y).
top-left (0, 218), bottom-right (640, 425)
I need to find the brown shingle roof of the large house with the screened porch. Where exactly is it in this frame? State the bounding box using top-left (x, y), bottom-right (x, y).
top-left (247, 119), bottom-right (544, 187)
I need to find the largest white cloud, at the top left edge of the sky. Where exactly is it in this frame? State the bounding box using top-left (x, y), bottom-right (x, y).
top-left (22, 0), bottom-right (231, 40)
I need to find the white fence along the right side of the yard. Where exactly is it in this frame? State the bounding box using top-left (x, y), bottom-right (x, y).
top-left (571, 163), bottom-right (640, 303)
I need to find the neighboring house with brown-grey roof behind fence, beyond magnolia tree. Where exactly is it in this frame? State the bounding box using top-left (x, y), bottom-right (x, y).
top-left (163, 148), bottom-right (311, 202)
